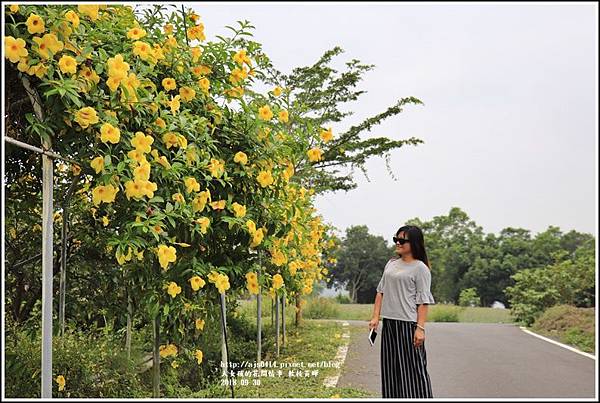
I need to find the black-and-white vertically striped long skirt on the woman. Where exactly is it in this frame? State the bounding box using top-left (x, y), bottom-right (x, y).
top-left (381, 318), bottom-right (433, 398)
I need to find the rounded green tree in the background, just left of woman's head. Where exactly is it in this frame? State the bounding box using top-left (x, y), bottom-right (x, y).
top-left (329, 225), bottom-right (394, 302)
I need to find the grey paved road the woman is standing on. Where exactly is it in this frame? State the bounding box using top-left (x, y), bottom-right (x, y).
top-left (326, 320), bottom-right (595, 398)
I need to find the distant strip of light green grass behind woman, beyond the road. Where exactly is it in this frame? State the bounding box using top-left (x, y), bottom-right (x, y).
top-left (240, 297), bottom-right (514, 323)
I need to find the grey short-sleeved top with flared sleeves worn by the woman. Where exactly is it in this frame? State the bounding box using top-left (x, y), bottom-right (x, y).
top-left (377, 258), bottom-right (435, 322)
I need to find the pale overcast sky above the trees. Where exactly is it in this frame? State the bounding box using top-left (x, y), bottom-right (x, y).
top-left (188, 2), bottom-right (598, 243)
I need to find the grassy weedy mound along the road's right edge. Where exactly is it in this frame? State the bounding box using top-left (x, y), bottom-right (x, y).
top-left (530, 305), bottom-right (596, 354)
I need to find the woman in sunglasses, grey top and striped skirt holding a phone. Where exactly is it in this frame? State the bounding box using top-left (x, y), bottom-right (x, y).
top-left (369, 225), bottom-right (435, 398)
